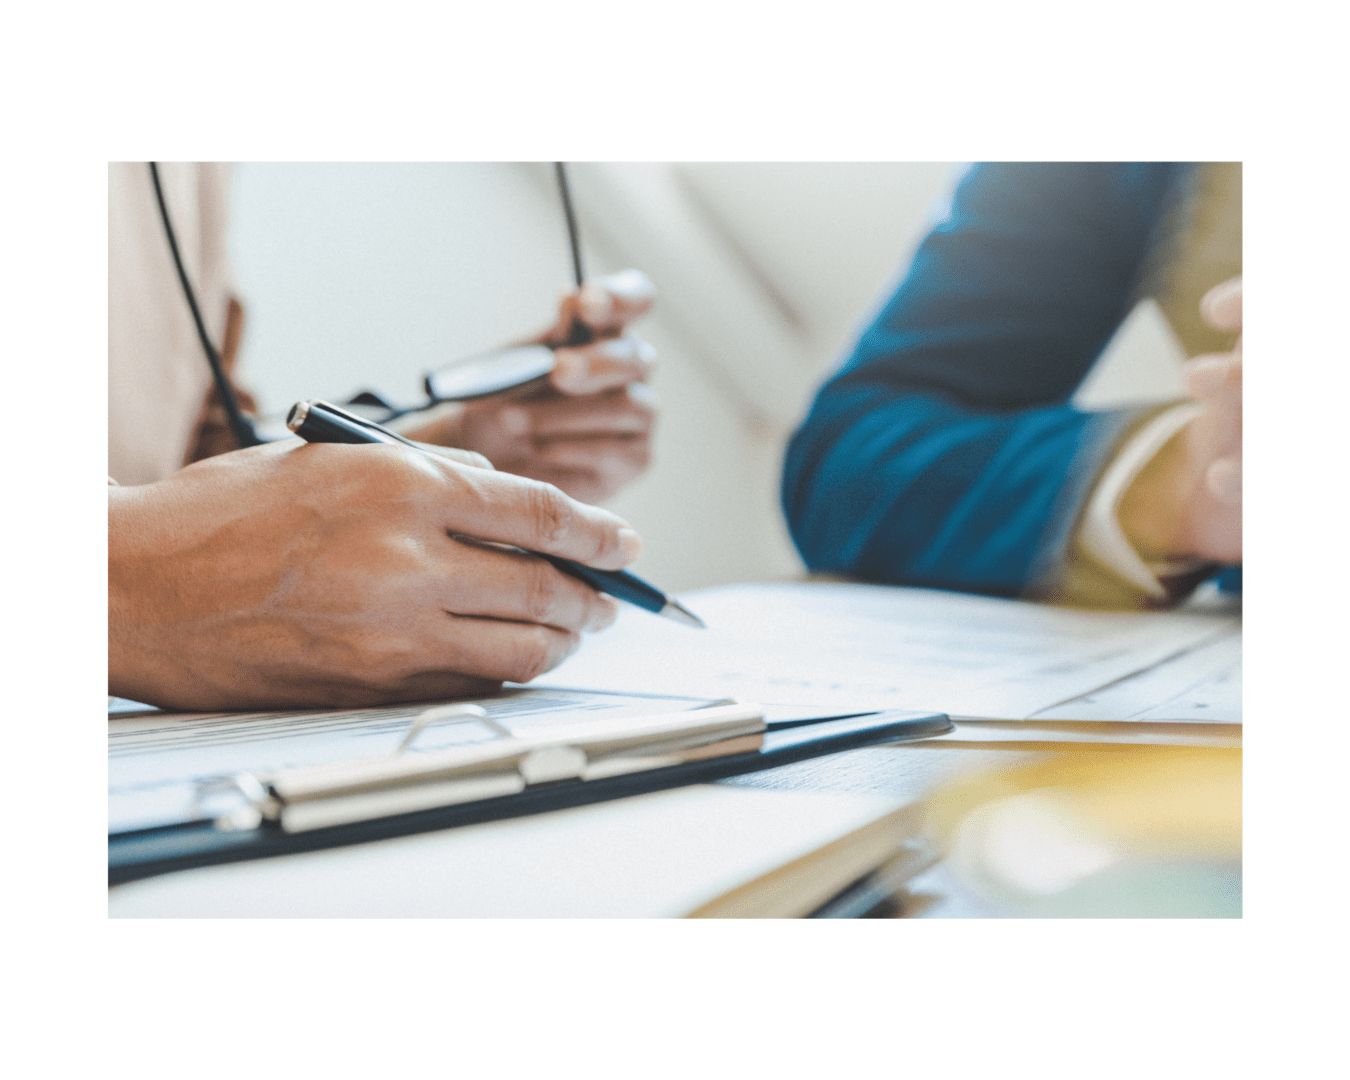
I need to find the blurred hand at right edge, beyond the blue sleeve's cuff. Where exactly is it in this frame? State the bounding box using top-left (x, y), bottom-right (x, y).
top-left (1121, 278), bottom-right (1242, 563)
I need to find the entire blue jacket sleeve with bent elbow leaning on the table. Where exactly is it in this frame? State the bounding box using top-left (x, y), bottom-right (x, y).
top-left (783, 163), bottom-right (1179, 595)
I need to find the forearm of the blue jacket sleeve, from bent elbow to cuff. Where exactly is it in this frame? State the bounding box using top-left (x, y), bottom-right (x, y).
top-left (783, 386), bottom-right (1131, 595)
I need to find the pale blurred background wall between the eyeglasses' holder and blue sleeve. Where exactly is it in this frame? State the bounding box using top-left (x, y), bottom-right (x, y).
top-left (231, 163), bottom-right (960, 591)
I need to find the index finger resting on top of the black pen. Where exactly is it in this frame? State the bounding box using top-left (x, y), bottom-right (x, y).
top-left (427, 459), bottom-right (643, 570)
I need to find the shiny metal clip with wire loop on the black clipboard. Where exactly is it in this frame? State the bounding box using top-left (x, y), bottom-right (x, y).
top-left (205, 702), bottom-right (765, 833)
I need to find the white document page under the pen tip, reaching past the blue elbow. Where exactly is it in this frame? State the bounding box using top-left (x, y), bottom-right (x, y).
top-left (539, 582), bottom-right (1241, 720)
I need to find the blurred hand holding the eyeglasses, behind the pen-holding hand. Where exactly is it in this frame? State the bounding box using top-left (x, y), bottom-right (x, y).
top-left (401, 270), bottom-right (656, 502)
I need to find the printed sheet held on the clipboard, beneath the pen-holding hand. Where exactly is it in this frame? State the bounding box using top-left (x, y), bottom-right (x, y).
top-left (108, 689), bottom-right (707, 833)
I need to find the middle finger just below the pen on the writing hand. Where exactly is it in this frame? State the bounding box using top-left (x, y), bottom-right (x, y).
top-left (433, 536), bottom-right (618, 630)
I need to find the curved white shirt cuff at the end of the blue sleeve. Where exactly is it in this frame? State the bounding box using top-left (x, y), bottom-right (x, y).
top-left (1081, 402), bottom-right (1202, 599)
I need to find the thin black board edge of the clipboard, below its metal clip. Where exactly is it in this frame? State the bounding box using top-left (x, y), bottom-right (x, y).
top-left (108, 710), bottom-right (953, 886)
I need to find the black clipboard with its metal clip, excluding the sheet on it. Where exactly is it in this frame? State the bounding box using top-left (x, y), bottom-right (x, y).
top-left (108, 702), bottom-right (953, 886)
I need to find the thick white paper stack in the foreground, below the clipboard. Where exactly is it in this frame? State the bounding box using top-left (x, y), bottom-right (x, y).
top-left (108, 784), bottom-right (933, 918)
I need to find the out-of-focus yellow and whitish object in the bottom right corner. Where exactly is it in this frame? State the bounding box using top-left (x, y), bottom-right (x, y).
top-left (927, 747), bottom-right (1242, 918)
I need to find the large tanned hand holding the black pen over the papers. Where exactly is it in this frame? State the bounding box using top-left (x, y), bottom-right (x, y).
top-left (108, 441), bottom-right (641, 710)
